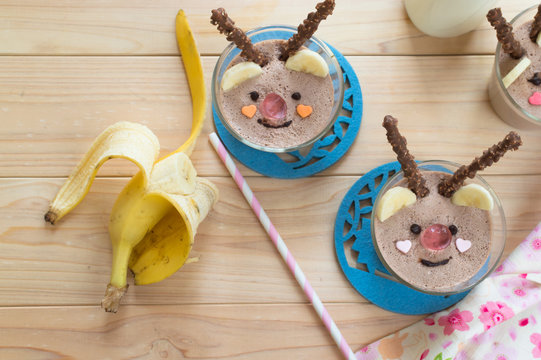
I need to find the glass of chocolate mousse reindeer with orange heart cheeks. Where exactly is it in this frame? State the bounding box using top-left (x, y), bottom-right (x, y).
top-left (212, 1), bottom-right (344, 153)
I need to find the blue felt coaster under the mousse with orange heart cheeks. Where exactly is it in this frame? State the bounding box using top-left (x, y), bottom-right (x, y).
top-left (212, 45), bottom-right (363, 179)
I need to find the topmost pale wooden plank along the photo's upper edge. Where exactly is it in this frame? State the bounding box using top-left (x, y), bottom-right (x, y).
top-left (0, 0), bottom-right (532, 55)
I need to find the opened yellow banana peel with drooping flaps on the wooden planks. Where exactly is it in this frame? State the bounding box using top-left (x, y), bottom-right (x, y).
top-left (46, 10), bottom-right (218, 312)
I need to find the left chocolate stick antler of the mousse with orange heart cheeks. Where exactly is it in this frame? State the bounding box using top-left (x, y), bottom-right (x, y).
top-left (210, 8), bottom-right (269, 66)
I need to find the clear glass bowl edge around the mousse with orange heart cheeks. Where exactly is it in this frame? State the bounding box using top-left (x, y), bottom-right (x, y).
top-left (212, 25), bottom-right (344, 153)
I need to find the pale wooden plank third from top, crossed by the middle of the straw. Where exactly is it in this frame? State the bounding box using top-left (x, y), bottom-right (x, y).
top-left (0, 175), bottom-right (541, 306)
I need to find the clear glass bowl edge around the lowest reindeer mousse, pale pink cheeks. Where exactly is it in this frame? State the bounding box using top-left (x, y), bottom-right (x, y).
top-left (371, 160), bottom-right (506, 295)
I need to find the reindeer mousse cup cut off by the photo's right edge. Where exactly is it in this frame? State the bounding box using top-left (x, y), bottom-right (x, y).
top-left (487, 5), bottom-right (541, 129)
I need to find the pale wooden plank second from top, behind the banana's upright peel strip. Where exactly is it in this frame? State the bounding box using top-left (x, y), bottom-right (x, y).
top-left (0, 56), bottom-right (541, 177)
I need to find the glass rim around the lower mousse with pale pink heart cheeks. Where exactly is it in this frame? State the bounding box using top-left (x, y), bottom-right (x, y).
top-left (370, 160), bottom-right (507, 296)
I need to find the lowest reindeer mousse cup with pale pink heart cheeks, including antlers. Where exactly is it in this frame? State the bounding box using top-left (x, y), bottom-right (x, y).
top-left (371, 116), bottom-right (522, 295)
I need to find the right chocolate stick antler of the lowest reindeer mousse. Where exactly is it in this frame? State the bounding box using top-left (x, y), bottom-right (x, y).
top-left (438, 131), bottom-right (522, 197)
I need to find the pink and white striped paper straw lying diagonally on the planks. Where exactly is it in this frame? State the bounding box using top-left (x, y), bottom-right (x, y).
top-left (209, 133), bottom-right (356, 360)
